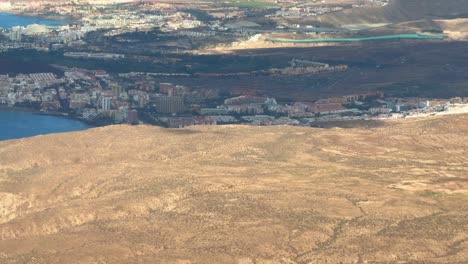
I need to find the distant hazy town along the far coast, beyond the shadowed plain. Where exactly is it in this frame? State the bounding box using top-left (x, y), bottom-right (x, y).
top-left (0, 0), bottom-right (388, 53)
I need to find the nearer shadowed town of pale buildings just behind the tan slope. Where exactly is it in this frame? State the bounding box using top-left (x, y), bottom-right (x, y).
top-left (0, 68), bottom-right (468, 128)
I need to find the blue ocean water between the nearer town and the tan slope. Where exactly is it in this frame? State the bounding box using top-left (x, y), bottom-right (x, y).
top-left (0, 110), bottom-right (90, 140)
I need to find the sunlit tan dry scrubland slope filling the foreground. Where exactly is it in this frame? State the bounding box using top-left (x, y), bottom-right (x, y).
top-left (0, 115), bottom-right (468, 264)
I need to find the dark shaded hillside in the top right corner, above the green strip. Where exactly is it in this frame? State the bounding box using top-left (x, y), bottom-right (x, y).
top-left (320, 0), bottom-right (468, 25)
